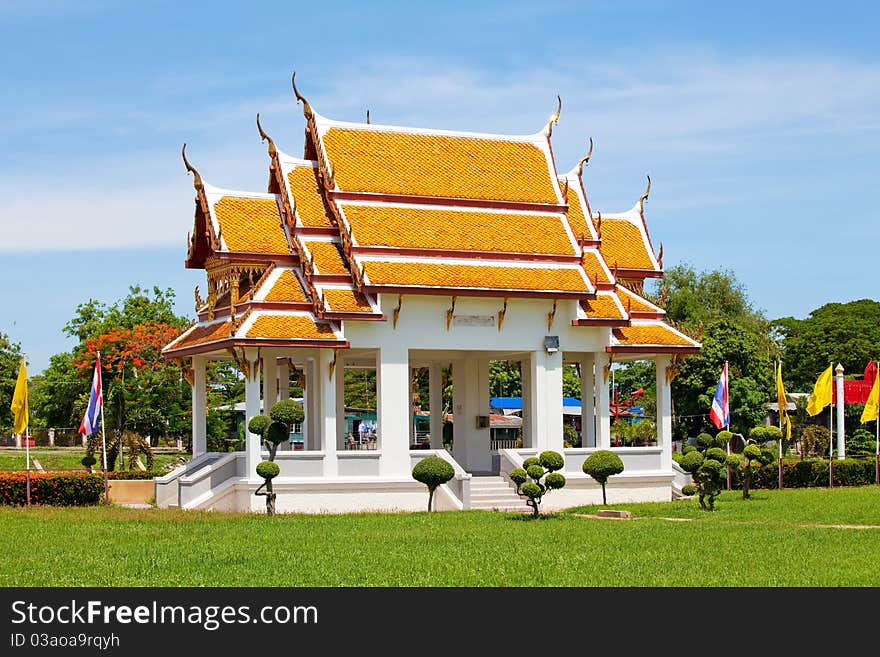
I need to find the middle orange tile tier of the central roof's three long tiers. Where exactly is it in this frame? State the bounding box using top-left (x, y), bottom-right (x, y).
top-left (342, 204), bottom-right (576, 255)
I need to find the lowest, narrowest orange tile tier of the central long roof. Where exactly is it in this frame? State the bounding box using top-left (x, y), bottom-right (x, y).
top-left (364, 261), bottom-right (590, 293)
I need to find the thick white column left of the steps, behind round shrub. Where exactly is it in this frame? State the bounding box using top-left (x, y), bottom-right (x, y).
top-left (376, 341), bottom-right (410, 477)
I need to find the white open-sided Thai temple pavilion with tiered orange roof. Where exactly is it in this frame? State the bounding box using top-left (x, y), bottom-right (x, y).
top-left (156, 74), bottom-right (699, 512)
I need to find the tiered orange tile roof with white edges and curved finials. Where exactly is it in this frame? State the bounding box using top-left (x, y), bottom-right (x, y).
top-left (165, 77), bottom-right (698, 357)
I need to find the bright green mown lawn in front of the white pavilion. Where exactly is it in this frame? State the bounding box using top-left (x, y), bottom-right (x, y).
top-left (0, 486), bottom-right (880, 586)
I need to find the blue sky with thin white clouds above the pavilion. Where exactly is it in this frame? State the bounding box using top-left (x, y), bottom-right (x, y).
top-left (0, 0), bottom-right (880, 372)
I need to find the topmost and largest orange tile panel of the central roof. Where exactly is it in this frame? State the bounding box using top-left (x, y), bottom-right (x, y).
top-left (323, 127), bottom-right (558, 203)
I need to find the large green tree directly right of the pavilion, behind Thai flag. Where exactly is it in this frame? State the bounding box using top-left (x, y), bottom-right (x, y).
top-left (655, 265), bottom-right (777, 437)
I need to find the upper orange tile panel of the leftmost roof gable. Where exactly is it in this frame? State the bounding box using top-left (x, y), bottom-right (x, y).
top-left (214, 196), bottom-right (290, 254)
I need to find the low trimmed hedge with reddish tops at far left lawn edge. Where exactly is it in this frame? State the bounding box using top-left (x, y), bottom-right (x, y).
top-left (0, 472), bottom-right (104, 506)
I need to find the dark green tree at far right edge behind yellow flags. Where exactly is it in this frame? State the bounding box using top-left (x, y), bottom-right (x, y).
top-left (772, 299), bottom-right (880, 391)
